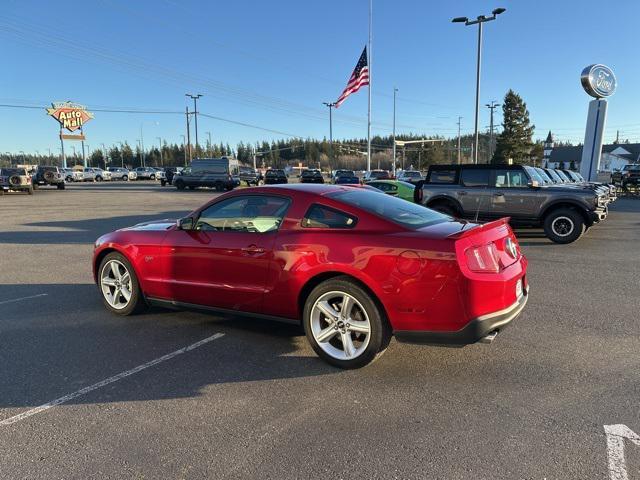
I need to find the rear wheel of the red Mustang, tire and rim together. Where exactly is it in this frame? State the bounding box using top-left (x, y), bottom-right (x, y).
top-left (303, 277), bottom-right (391, 369)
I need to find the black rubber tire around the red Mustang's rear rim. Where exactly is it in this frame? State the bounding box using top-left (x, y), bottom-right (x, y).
top-left (302, 276), bottom-right (392, 369)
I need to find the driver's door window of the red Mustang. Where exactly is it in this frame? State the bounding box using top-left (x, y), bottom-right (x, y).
top-left (195, 195), bottom-right (290, 233)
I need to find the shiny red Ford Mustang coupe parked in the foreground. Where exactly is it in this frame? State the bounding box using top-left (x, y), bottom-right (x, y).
top-left (93, 185), bottom-right (528, 368)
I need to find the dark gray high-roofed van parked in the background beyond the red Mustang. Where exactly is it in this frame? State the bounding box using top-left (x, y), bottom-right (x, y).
top-left (171, 157), bottom-right (238, 192)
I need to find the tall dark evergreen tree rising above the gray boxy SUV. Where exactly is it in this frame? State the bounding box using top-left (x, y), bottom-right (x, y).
top-left (492, 90), bottom-right (535, 163)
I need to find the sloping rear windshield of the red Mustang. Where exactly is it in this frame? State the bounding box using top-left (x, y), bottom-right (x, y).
top-left (327, 189), bottom-right (449, 229)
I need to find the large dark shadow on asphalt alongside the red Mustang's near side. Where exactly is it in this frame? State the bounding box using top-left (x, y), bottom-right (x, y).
top-left (0, 284), bottom-right (339, 410)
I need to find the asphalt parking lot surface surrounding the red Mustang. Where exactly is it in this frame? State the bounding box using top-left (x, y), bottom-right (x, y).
top-left (0, 182), bottom-right (640, 480)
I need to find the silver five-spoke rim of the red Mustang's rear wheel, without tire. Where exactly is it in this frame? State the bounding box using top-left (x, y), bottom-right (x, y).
top-left (311, 291), bottom-right (371, 360)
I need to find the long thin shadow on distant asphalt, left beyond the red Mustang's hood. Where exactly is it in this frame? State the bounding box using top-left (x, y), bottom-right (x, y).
top-left (0, 210), bottom-right (189, 245)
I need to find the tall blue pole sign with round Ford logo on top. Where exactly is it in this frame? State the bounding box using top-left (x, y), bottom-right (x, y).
top-left (580, 64), bottom-right (617, 182)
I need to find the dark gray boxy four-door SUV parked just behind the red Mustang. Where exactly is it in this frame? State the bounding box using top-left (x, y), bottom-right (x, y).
top-left (414, 165), bottom-right (608, 243)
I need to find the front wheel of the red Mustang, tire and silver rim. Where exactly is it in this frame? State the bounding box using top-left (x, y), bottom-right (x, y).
top-left (98, 252), bottom-right (146, 315)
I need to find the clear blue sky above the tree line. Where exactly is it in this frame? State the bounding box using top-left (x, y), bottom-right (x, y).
top-left (0, 0), bottom-right (640, 154)
